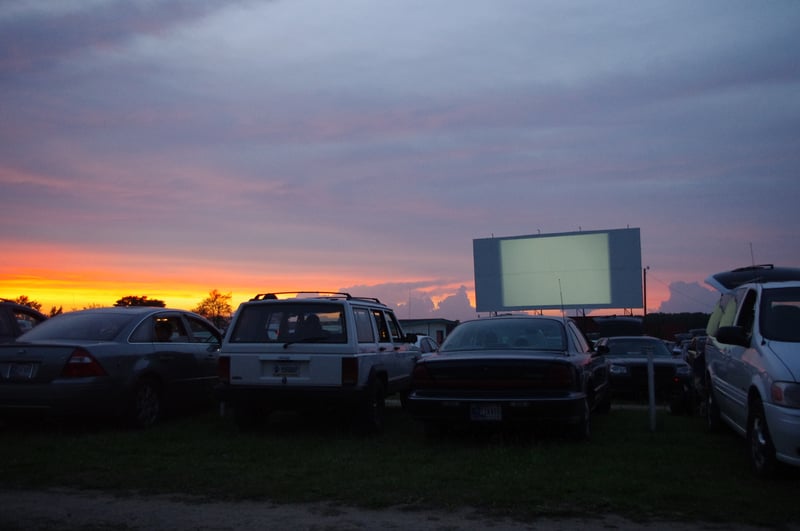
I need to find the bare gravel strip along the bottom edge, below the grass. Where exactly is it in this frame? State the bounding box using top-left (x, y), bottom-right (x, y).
top-left (0, 489), bottom-right (780, 531)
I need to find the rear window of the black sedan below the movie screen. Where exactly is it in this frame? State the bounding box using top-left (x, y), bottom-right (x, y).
top-left (440, 318), bottom-right (566, 352)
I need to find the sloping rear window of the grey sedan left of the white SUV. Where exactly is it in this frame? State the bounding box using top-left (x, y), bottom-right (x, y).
top-left (18, 312), bottom-right (136, 341)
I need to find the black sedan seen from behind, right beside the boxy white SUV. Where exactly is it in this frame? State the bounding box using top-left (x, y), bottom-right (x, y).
top-left (408, 316), bottom-right (610, 439)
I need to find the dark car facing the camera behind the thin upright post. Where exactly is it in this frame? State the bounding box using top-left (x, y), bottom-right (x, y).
top-left (595, 336), bottom-right (694, 414)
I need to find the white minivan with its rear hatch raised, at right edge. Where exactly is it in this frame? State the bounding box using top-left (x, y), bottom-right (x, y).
top-left (705, 265), bottom-right (800, 476)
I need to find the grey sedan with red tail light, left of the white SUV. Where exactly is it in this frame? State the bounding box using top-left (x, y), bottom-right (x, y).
top-left (0, 307), bottom-right (221, 427)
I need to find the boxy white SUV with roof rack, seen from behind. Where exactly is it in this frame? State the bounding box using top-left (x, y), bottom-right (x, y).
top-left (218, 292), bottom-right (419, 431)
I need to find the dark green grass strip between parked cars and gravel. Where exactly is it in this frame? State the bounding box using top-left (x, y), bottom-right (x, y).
top-left (0, 408), bottom-right (800, 526)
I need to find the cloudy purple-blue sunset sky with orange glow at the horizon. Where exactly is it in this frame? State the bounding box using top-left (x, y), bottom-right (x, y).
top-left (0, 0), bottom-right (800, 320)
